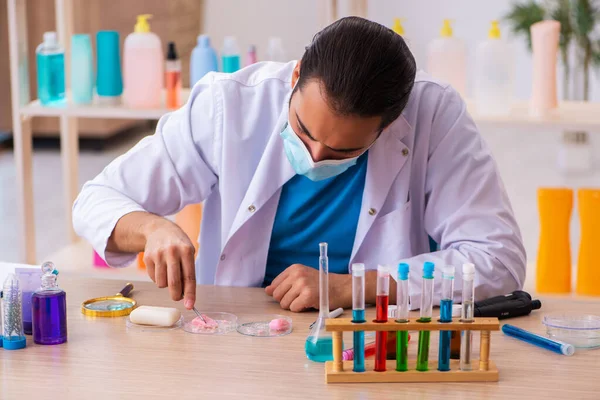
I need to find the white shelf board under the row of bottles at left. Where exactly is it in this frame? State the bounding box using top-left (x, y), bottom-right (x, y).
top-left (21, 89), bottom-right (190, 119)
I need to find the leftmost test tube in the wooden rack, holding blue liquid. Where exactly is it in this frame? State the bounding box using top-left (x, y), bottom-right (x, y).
top-left (352, 264), bottom-right (367, 372)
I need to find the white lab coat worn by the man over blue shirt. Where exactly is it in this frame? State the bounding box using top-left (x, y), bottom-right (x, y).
top-left (73, 62), bottom-right (525, 307)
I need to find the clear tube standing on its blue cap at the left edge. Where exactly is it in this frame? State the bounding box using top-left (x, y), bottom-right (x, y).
top-left (2, 274), bottom-right (27, 350)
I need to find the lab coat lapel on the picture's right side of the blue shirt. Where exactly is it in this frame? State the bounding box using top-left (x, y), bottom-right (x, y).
top-left (350, 116), bottom-right (411, 262)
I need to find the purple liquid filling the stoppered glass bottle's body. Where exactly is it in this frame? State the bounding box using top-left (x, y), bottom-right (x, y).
top-left (31, 290), bottom-right (67, 344)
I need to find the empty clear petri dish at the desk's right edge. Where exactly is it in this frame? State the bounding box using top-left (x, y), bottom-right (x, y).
top-left (542, 313), bottom-right (600, 349)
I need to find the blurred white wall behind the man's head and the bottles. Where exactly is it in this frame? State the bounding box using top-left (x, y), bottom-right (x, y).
top-left (203, 0), bottom-right (600, 101)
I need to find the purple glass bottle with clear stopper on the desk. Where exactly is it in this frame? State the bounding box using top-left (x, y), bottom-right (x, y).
top-left (31, 262), bottom-right (67, 344)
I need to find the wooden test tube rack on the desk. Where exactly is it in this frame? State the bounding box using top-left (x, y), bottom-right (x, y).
top-left (325, 318), bottom-right (500, 383)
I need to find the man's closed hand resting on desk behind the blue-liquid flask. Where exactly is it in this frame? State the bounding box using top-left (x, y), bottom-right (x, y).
top-left (265, 264), bottom-right (352, 312)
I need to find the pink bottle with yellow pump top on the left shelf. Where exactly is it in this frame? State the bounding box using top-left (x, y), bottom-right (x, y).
top-left (123, 14), bottom-right (164, 108)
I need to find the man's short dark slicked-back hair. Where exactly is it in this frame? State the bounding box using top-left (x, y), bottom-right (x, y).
top-left (295, 17), bottom-right (416, 129)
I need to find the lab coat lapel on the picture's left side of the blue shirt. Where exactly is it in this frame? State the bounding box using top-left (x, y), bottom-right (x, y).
top-left (227, 100), bottom-right (296, 241)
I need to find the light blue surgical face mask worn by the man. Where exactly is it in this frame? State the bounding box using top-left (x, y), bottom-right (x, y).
top-left (281, 123), bottom-right (366, 181)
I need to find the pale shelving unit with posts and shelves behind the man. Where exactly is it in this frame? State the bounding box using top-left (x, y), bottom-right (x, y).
top-left (7, 0), bottom-right (600, 264)
